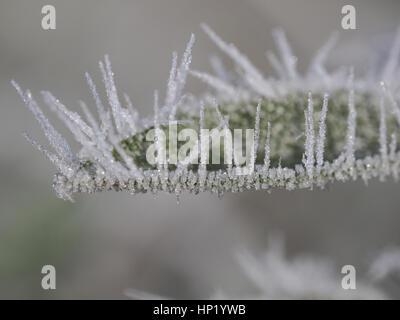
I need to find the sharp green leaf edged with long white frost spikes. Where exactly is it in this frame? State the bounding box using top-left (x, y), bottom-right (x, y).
top-left (13, 25), bottom-right (400, 200)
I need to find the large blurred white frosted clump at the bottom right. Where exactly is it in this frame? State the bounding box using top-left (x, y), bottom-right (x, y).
top-left (213, 238), bottom-right (386, 299)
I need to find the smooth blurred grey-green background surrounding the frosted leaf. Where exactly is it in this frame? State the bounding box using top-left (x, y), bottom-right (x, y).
top-left (0, 0), bottom-right (400, 299)
